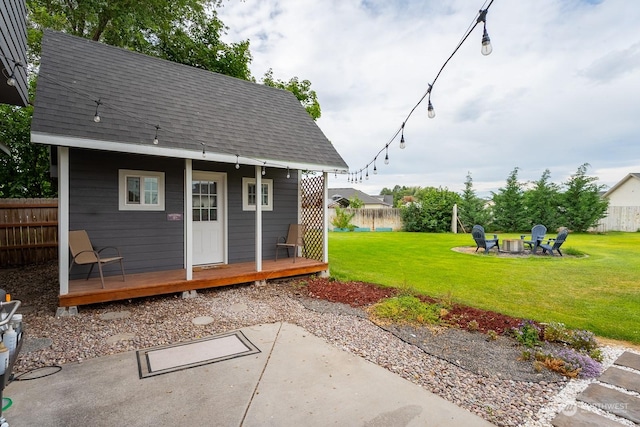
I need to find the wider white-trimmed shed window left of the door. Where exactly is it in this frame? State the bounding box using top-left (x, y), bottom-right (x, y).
top-left (118, 169), bottom-right (164, 211)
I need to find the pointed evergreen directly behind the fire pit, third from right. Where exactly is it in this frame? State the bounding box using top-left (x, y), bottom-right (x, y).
top-left (492, 167), bottom-right (531, 232)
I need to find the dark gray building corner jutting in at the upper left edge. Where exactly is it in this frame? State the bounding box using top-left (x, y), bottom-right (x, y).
top-left (0, 0), bottom-right (29, 107)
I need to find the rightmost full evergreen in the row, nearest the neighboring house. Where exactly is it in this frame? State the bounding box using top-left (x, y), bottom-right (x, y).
top-left (562, 163), bottom-right (609, 232)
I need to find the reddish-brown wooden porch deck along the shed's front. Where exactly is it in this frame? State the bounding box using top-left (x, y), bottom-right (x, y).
top-left (59, 258), bottom-right (329, 307)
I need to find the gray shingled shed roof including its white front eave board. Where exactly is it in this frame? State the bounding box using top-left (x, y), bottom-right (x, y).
top-left (31, 30), bottom-right (348, 171)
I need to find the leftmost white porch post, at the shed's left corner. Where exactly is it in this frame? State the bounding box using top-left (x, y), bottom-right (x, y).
top-left (58, 147), bottom-right (69, 295)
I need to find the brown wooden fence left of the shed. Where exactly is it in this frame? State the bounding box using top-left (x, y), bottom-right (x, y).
top-left (0, 199), bottom-right (58, 268)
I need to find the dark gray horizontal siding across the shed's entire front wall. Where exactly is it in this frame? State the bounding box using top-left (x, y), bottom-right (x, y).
top-left (69, 149), bottom-right (298, 279)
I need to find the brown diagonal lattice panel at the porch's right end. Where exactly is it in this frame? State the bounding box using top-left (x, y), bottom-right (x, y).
top-left (300, 175), bottom-right (324, 261)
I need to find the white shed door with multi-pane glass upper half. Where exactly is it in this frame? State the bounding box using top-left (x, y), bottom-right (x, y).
top-left (191, 171), bottom-right (226, 265)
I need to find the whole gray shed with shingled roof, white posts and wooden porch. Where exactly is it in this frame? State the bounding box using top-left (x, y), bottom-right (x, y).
top-left (31, 30), bottom-right (348, 306)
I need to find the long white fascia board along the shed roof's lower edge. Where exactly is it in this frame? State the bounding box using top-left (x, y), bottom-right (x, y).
top-left (31, 132), bottom-right (349, 174)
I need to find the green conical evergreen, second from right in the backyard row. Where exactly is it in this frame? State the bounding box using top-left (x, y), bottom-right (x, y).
top-left (524, 169), bottom-right (562, 230)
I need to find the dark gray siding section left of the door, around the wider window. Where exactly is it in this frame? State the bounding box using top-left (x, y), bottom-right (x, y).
top-left (69, 149), bottom-right (184, 279)
